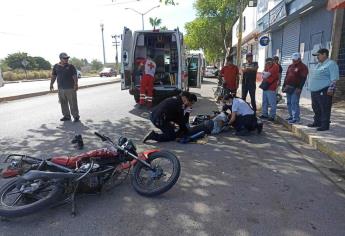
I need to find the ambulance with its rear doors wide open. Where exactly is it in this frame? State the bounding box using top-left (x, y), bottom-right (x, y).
top-left (121, 27), bottom-right (197, 104)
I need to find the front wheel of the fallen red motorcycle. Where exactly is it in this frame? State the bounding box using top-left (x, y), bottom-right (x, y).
top-left (131, 151), bottom-right (181, 197)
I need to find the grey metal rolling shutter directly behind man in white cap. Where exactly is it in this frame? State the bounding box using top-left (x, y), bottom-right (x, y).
top-left (281, 19), bottom-right (301, 83)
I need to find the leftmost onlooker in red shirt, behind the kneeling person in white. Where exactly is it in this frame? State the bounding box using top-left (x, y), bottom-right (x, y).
top-left (220, 57), bottom-right (239, 96)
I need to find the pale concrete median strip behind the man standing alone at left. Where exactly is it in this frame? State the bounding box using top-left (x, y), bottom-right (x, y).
top-left (0, 77), bottom-right (120, 102)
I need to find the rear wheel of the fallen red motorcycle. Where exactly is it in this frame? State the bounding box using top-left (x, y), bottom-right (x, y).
top-left (0, 177), bottom-right (63, 217)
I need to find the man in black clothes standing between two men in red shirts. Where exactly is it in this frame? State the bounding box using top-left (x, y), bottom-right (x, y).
top-left (242, 52), bottom-right (258, 112)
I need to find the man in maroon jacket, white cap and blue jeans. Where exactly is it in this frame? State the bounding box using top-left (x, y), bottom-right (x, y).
top-left (283, 52), bottom-right (308, 124)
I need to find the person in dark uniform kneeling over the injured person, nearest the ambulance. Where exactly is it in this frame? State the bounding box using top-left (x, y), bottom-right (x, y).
top-left (143, 92), bottom-right (197, 143)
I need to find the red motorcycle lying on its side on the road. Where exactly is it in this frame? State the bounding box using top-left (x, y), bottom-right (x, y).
top-left (0, 132), bottom-right (181, 217)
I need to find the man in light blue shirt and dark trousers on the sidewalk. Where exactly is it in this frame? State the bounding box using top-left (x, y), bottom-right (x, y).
top-left (308, 48), bottom-right (339, 131)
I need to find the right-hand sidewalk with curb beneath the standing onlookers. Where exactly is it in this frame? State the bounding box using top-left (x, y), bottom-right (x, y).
top-left (253, 84), bottom-right (345, 167)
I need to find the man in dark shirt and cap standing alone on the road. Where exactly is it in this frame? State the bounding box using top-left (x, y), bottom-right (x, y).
top-left (50, 52), bottom-right (80, 122)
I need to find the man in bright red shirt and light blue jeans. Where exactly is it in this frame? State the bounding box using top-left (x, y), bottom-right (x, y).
top-left (260, 57), bottom-right (279, 121)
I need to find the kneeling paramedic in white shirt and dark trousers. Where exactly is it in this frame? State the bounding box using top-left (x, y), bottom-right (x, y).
top-left (224, 94), bottom-right (263, 136)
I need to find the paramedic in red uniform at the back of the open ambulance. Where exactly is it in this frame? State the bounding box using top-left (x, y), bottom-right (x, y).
top-left (139, 56), bottom-right (156, 108)
